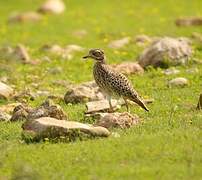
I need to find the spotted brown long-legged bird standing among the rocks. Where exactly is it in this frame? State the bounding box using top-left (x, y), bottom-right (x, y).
top-left (83, 48), bottom-right (149, 112)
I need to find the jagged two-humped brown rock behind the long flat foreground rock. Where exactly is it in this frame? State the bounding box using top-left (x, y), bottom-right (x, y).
top-left (11, 100), bottom-right (67, 121)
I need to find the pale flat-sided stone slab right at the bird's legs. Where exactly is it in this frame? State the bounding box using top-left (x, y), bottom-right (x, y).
top-left (86, 99), bottom-right (123, 114)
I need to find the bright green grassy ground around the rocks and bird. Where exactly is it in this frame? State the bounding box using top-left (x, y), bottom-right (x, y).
top-left (0, 0), bottom-right (202, 179)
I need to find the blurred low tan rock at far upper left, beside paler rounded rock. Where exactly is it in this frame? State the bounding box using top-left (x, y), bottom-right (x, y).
top-left (8, 11), bottom-right (42, 23)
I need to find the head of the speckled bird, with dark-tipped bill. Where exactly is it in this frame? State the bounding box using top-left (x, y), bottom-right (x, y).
top-left (83, 49), bottom-right (105, 62)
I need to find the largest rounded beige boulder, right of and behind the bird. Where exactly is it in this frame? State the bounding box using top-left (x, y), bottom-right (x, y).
top-left (138, 37), bottom-right (192, 67)
